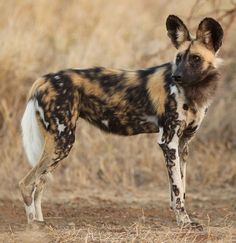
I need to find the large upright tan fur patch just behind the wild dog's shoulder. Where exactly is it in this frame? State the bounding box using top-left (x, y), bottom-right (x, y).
top-left (147, 71), bottom-right (166, 114)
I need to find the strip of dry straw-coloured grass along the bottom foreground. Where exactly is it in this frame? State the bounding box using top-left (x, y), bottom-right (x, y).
top-left (0, 224), bottom-right (232, 243)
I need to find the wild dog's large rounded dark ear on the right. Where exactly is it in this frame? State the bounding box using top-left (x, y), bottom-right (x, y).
top-left (197, 18), bottom-right (224, 52)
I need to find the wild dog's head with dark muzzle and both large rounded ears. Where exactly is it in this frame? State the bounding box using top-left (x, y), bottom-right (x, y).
top-left (166, 15), bottom-right (223, 86)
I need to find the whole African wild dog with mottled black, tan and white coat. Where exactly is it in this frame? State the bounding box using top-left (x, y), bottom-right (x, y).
top-left (19, 15), bottom-right (223, 227)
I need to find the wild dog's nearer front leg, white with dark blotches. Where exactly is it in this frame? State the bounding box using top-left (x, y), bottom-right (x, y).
top-left (159, 134), bottom-right (191, 226)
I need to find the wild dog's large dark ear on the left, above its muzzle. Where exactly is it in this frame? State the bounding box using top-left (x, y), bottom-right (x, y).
top-left (166, 15), bottom-right (191, 49)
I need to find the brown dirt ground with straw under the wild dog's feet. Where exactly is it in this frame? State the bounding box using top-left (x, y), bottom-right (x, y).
top-left (0, 189), bottom-right (236, 242)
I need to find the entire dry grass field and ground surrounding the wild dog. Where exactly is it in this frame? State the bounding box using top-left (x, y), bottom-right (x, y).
top-left (0, 0), bottom-right (236, 242)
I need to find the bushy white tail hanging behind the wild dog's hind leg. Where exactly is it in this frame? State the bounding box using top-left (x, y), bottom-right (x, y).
top-left (21, 100), bottom-right (44, 166)
